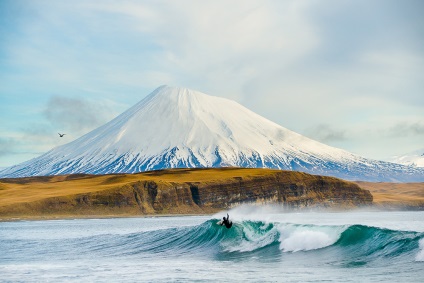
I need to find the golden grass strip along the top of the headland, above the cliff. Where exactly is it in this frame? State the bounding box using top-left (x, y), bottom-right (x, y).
top-left (0, 168), bottom-right (284, 207)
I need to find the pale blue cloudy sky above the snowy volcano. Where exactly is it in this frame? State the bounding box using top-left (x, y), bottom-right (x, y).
top-left (0, 0), bottom-right (424, 167)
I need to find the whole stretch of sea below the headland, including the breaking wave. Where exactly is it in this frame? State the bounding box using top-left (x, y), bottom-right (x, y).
top-left (0, 206), bottom-right (424, 282)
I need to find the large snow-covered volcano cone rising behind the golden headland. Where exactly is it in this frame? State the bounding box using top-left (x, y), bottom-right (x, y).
top-left (0, 86), bottom-right (424, 181)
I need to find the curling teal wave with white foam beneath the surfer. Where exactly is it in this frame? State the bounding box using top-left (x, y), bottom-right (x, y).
top-left (117, 219), bottom-right (424, 264)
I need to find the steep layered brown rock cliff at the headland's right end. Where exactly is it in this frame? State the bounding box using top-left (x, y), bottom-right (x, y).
top-left (190, 172), bottom-right (372, 208)
